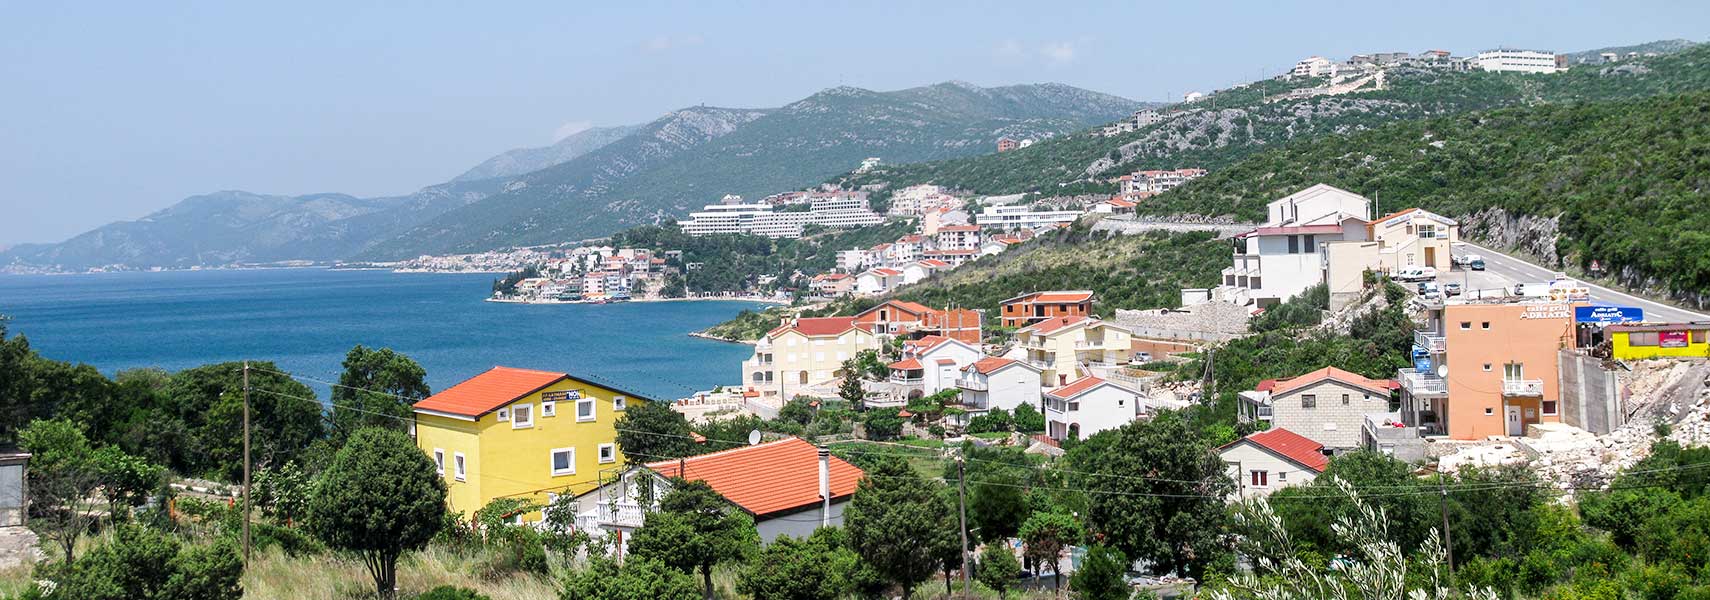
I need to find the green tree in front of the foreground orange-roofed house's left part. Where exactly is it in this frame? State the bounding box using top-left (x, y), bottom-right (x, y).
top-left (629, 480), bottom-right (759, 600)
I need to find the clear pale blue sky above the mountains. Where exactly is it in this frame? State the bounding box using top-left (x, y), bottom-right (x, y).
top-left (0, 0), bottom-right (1710, 246)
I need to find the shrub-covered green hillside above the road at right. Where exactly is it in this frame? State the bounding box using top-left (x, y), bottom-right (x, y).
top-left (1142, 92), bottom-right (1710, 308)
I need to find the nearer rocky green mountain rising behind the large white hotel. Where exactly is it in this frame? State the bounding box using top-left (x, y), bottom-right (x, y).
top-left (364, 82), bottom-right (1141, 260)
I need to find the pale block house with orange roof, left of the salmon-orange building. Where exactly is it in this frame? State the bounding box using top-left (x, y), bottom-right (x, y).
top-left (1240, 366), bottom-right (1397, 451)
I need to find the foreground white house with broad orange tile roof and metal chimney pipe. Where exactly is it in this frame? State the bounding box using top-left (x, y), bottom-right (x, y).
top-left (576, 438), bottom-right (865, 549)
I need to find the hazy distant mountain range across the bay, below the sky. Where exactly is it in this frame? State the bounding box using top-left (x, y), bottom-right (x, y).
top-left (0, 82), bottom-right (1147, 272)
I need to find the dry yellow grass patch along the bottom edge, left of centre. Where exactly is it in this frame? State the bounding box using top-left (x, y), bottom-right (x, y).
top-left (243, 547), bottom-right (557, 600)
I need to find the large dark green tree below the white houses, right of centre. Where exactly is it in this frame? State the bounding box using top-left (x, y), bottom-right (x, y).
top-left (1069, 410), bottom-right (1235, 579)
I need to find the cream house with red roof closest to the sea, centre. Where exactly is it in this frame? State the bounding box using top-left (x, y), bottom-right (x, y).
top-left (742, 316), bottom-right (879, 402)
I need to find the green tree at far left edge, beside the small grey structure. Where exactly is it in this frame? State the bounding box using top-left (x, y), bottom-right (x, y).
top-left (17, 419), bottom-right (103, 562)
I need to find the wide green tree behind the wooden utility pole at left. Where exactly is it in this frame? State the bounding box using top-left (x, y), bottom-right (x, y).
top-left (162, 362), bottom-right (327, 480)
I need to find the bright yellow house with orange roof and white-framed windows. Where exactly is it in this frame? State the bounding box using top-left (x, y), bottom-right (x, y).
top-left (414, 368), bottom-right (648, 520)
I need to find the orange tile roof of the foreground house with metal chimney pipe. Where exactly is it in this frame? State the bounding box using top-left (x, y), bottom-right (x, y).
top-left (646, 438), bottom-right (867, 516)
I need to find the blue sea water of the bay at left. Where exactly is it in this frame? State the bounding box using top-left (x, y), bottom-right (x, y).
top-left (0, 268), bottom-right (752, 400)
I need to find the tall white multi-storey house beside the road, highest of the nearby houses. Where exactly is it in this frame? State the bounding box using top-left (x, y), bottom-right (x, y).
top-left (1210, 183), bottom-right (1371, 308)
